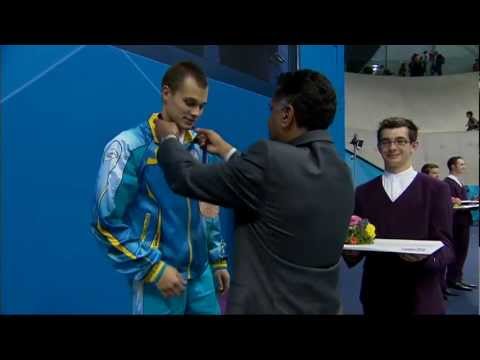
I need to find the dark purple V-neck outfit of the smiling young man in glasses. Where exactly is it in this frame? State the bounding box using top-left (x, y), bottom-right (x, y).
top-left (349, 173), bottom-right (453, 314)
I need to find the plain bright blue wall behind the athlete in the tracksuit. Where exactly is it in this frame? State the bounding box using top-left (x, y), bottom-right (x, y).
top-left (0, 46), bottom-right (344, 314)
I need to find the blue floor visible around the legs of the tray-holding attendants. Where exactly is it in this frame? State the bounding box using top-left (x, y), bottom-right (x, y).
top-left (340, 226), bottom-right (480, 315)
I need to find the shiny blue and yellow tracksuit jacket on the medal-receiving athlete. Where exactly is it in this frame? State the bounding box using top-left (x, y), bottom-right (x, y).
top-left (92, 113), bottom-right (227, 283)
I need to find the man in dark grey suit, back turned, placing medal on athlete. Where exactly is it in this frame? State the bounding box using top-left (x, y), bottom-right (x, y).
top-left (152, 70), bottom-right (353, 314)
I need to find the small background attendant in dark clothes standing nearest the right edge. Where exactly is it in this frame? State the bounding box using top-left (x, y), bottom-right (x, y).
top-left (445, 156), bottom-right (477, 291)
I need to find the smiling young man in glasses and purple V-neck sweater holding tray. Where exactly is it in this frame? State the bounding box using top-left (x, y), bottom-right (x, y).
top-left (344, 117), bottom-right (453, 315)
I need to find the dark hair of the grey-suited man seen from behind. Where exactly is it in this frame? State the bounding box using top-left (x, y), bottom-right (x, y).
top-left (273, 69), bottom-right (337, 130)
